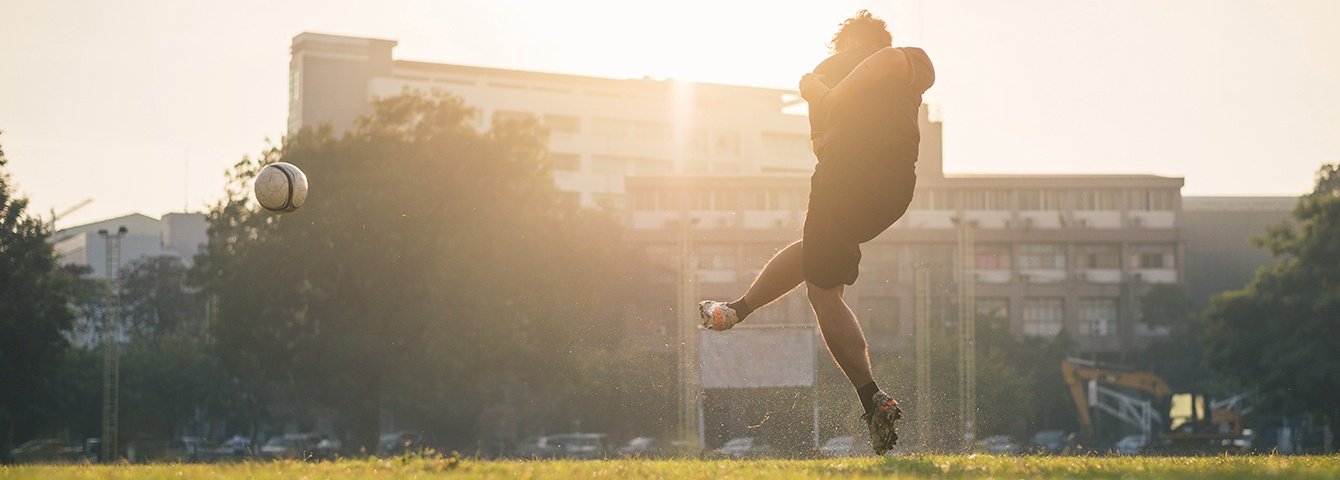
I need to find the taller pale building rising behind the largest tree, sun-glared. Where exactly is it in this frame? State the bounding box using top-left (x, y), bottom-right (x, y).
top-left (288, 34), bottom-right (939, 208)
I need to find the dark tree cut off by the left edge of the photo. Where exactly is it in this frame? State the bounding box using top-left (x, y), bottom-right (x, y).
top-left (0, 132), bottom-right (74, 456)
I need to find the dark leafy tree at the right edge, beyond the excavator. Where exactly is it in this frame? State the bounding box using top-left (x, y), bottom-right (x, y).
top-left (1201, 165), bottom-right (1340, 445)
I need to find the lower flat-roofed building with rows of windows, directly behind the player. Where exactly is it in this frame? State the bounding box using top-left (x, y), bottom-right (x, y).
top-left (627, 166), bottom-right (1183, 353)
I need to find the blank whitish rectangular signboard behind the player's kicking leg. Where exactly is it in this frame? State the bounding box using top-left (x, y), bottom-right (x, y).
top-left (698, 324), bottom-right (815, 389)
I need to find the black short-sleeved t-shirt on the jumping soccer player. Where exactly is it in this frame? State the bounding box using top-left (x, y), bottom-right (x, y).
top-left (809, 47), bottom-right (935, 162)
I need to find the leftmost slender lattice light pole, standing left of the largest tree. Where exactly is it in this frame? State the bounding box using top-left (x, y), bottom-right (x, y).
top-left (98, 225), bottom-right (127, 464)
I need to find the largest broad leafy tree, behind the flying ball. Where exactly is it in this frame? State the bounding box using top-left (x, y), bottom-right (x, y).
top-left (192, 94), bottom-right (635, 451)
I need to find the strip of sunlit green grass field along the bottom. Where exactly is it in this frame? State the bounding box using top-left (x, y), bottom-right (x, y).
top-left (0, 455), bottom-right (1340, 480)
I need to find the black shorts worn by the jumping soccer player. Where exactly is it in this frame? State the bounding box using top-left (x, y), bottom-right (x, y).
top-left (801, 148), bottom-right (917, 288)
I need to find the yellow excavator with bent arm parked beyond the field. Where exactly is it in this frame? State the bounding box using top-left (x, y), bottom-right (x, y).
top-left (1061, 358), bottom-right (1246, 455)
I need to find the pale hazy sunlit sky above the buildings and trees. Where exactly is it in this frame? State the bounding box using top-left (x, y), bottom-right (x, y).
top-left (0, 0), bottom-right (1340, 227)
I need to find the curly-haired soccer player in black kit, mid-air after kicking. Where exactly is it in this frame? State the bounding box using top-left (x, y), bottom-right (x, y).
top-left (698, 11), bottom-right (935, 455)
